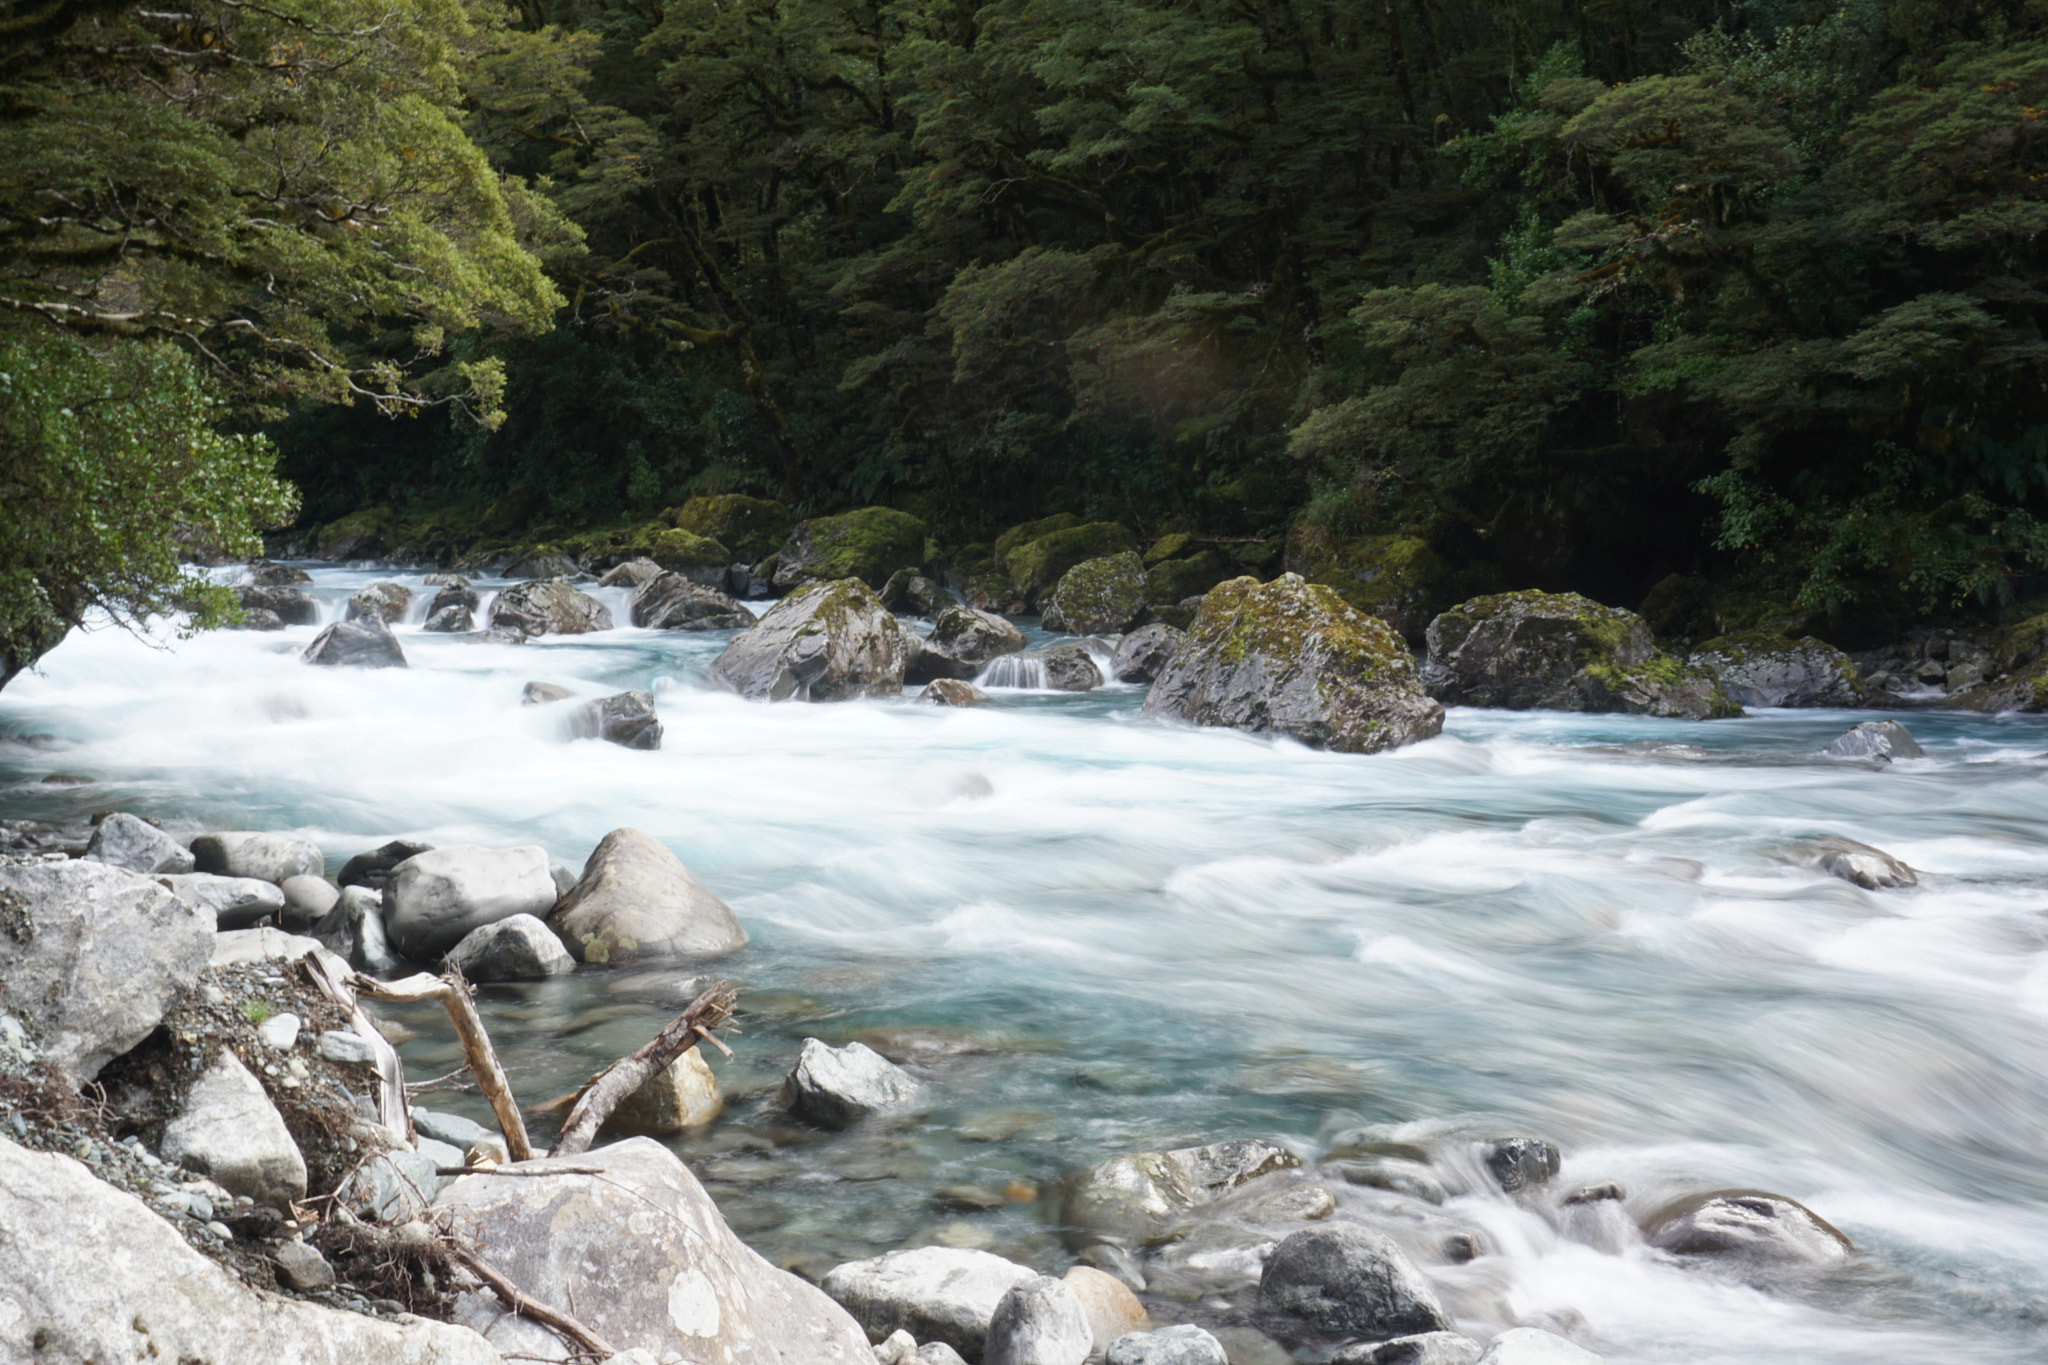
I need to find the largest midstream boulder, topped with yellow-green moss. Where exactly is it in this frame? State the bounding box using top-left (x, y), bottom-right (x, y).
top-left (1145, 573), bottom-right (1444, 753)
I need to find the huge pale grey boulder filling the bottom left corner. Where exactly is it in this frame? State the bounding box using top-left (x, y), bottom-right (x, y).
top-left (0, 1138), bottom-right (495, 1365)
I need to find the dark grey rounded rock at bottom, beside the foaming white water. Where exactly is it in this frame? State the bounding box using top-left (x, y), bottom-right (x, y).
top-left (1260, 1224), bottom-right (1450, 1336)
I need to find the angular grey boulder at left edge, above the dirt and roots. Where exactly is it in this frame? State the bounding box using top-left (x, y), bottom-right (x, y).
top-left (0, 862), bottom-right (215, 1081)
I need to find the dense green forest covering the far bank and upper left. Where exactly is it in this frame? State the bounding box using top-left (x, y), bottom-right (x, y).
top-left (0, 0), bottom-right (2048, 655)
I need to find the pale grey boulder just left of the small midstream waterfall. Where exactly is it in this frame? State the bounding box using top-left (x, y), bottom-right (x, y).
top-left (711, 579), bottom-right (909, 702)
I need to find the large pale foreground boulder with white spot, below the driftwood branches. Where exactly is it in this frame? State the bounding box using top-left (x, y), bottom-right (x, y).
top-left (434, 1138), bottom-right (874, 1365)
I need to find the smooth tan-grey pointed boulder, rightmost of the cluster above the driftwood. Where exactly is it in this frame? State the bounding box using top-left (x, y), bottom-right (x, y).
top-left (547, 829), bottom-right (748, 966)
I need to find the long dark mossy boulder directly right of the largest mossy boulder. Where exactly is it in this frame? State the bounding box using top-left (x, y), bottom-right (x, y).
top-left (1427, 591), bottom-right (1743, 720)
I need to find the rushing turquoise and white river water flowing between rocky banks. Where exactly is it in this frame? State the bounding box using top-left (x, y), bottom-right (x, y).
top-left (0, 569), bottom-right (2048, 1365)
